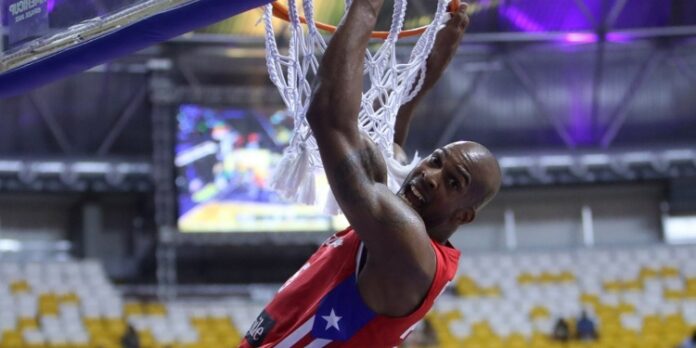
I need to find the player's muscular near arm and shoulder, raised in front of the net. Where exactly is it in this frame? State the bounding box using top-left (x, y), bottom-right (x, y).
top-left (307, 0), bottom-right (435, 315)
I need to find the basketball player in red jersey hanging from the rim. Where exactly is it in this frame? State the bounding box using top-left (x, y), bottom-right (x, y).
top-left (241, 0), bottom-right (500, 348)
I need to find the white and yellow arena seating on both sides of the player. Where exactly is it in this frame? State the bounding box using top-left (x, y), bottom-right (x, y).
top-left (0, 246), bottom-right (696, 348)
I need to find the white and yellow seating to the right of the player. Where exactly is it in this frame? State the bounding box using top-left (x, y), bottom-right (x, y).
top-left (427, 246), bottom-right (696, 348)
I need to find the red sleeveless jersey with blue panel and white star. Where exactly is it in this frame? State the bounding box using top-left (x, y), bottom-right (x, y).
top-left (240, 227), bottom-right (459, 348)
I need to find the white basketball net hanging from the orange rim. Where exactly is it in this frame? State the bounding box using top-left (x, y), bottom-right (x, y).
top-left (264, 0), bottom-right (447, 213)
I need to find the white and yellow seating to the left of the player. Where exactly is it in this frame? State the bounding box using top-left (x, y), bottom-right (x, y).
top-left (0, 261), bottom-right (261, 348)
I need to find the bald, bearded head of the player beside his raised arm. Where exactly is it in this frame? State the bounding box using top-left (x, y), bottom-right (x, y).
top-left (397, 141), bottom-right (501, 241)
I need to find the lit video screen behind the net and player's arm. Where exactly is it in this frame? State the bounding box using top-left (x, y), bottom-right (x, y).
top-left (175, 105), bottom-right (347, 232)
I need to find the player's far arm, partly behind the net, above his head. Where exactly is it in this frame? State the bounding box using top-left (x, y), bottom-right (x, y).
top-left (394, 2), bottom-right (469, 153)
